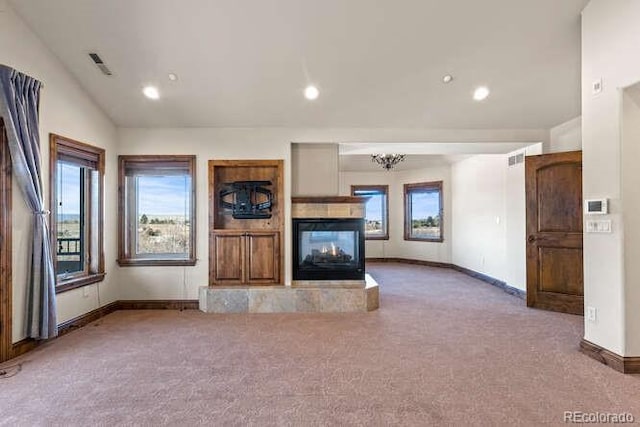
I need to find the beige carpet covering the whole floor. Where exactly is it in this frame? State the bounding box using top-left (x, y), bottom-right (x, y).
top-left (0, 264), bottom-right (640, 426)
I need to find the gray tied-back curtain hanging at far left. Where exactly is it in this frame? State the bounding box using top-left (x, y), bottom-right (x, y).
top-left (0, 65), bottom-right (58, 340)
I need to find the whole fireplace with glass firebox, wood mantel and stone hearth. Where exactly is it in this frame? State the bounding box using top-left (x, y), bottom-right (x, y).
top-left (200, 197), bottom-right (379, 313)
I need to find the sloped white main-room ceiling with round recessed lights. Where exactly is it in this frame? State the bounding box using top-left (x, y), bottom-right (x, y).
top-left (11, 0), bottom-right (588, 129)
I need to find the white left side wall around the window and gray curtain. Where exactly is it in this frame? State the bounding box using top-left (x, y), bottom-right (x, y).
top-left (0, 0), bottom-right (118, 342)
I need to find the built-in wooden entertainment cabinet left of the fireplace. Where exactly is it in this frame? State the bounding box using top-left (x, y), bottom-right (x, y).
top-left (209, 160), bottom-right (284, 286)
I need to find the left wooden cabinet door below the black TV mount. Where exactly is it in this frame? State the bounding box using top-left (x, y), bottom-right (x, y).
top-left (209, 231), bottom-right (245, 285)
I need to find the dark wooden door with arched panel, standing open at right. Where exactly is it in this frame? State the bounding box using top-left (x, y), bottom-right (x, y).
top-left (525, 151), bottom-right (584, 314)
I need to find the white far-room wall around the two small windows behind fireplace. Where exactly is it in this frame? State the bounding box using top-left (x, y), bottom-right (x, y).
top-left (340, 165), bottom-right (453, 263)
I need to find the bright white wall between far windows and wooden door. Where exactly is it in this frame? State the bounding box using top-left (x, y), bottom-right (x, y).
top-left (451, 144), bottom-right (542, 291)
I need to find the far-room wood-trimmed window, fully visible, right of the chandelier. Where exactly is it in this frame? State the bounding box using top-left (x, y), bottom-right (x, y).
top-left (404, 181), bottom-right (443, 242)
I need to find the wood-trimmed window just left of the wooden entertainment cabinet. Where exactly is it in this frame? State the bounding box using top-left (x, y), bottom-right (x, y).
top-left (118, 156), bottom-right (196, 266)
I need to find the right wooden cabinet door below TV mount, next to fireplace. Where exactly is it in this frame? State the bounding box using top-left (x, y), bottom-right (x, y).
top-left (245, 231), bottom-right (280, 284)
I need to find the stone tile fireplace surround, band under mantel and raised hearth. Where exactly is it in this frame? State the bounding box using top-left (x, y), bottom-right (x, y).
top-left (199, 197), bottom-right (379, 313)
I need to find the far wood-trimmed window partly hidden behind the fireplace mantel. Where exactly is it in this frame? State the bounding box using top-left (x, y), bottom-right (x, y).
top-left (351, 185), bottom-right (389, 240)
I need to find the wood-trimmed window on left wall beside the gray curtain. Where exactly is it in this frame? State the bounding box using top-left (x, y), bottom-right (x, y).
top-left (49, 134), bottom-right (105, 292)
